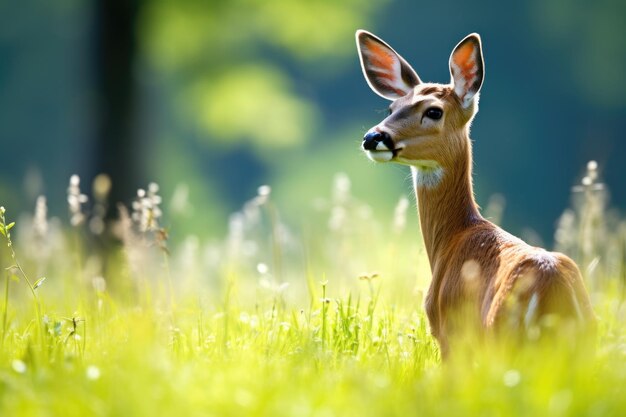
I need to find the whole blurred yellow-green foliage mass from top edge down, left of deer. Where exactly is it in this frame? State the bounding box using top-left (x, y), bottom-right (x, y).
top-left (141, 0), bottom-right (384, 148)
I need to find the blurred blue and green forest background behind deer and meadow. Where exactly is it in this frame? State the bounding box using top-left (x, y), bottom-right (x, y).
top-left (0, 0), bottom-right (626, 245)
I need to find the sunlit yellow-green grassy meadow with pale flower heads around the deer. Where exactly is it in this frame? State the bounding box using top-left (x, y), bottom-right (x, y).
top-left (0, 164), bottom-right (626, 417)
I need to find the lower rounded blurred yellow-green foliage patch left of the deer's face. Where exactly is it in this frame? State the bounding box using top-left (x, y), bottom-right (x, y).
top-left (181, 65), bottom-right (317, 149)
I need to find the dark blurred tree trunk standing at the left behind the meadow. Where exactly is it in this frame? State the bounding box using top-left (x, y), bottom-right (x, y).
top-left (92, 0), bottom-right (142, 208)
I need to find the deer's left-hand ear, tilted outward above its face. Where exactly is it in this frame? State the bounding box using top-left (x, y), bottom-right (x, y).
top-left (356, 30), bottom-right (421, 100)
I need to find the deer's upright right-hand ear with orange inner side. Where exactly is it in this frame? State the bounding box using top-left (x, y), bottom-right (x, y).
top-left (450, 33), bottom-right (485, 108)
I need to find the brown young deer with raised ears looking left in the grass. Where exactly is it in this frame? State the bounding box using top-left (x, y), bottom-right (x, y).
top-left (356, 30), bottom-right (595, 356)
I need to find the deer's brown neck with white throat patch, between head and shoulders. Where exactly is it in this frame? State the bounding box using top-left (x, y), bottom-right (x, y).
top-left (411, 131), bottom-right (482, 266)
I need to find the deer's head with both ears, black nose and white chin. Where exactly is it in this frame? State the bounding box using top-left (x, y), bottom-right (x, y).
top-left (356, 30), bottom-right (484, 186)
